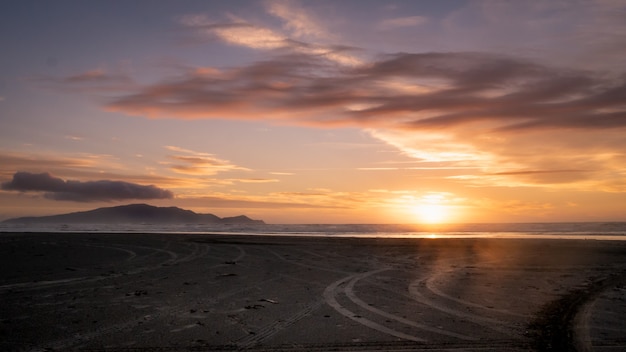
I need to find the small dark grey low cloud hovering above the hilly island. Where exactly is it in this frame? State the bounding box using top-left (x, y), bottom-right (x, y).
top-left (2, 171), bottom-right (174, 202)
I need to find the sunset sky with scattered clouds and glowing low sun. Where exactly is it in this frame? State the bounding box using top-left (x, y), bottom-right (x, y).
top-left (0, 0), bottom-right (626, 223)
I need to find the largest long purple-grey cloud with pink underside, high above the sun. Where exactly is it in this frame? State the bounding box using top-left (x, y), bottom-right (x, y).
top-left (107, 53), bottom-right (626, 131)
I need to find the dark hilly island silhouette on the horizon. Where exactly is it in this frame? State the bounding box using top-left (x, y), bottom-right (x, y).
top-left (3, 204), bottom-right (264, 224)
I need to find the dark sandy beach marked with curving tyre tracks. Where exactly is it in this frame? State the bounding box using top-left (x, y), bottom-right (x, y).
top-left (0, 233), bottom-right (626, 351)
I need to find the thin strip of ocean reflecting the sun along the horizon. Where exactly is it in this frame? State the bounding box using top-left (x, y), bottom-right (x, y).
top-left (0, 222), bottom-right (626, 240)
